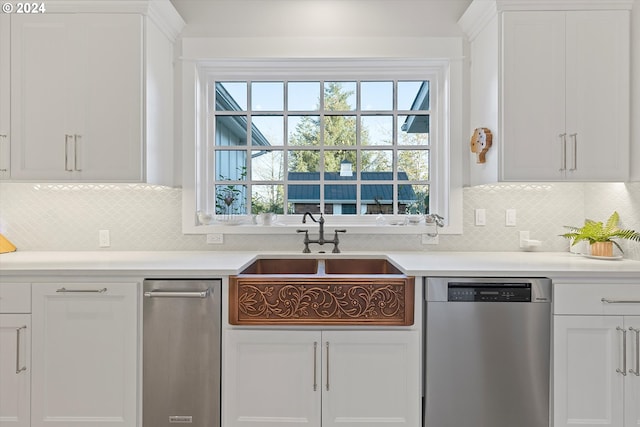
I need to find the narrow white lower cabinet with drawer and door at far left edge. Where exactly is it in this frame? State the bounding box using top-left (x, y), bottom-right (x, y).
top-left (0, 283), bottom-right (31, 427)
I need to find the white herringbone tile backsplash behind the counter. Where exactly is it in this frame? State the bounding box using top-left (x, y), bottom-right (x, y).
top-left (0, 183), bottom-right (640, 259)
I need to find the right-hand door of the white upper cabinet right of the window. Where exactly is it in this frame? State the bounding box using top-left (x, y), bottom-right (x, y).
top-left (566, 10), bottom-right (630, 181)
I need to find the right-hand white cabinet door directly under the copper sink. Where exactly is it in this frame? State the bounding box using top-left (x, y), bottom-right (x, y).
top-left (322, 331), bottom-right (421, 427)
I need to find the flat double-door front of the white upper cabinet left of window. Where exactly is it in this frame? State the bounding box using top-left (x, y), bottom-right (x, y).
top-left (11, 14), bottom-right (143, 181)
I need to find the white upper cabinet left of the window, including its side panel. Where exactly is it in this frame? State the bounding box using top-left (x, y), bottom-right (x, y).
top-left (5, 2), bottom-right (184, 185)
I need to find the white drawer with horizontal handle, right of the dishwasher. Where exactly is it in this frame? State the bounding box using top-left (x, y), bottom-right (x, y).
top-left (553, 282), bottom-right (640, 315)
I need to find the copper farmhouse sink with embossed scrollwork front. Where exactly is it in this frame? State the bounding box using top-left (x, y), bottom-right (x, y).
top-left (229, 258), bottom-right (415, 326)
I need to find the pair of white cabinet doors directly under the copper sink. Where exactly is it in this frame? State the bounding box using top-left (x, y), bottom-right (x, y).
top-left (222, 330), bottom-right (421, 427)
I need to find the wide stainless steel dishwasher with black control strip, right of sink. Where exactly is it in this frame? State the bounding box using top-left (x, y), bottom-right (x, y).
top-left (424, 277), bottom-right (551, 427)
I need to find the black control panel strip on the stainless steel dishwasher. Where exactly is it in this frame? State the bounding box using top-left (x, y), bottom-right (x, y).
top-left (447, 282), bottom-right (531, 302)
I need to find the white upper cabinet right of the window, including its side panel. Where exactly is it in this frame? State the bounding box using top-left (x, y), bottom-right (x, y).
top-left (460, 1), bottom-right (631, 184)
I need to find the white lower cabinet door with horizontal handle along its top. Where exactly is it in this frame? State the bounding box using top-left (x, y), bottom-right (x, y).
top-left (31, 283), bottom-right (138, 427)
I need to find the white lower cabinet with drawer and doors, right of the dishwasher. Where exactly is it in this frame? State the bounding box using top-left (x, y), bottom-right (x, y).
top-left (553, 284), bottom-right (640, 427)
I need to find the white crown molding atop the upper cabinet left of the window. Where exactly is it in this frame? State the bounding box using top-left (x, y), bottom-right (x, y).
top-left (35, 0), bottom-right (185, 42)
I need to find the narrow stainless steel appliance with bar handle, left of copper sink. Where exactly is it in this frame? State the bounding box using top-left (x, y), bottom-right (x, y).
top-left (142, 279), bottom-right (221, 427)
